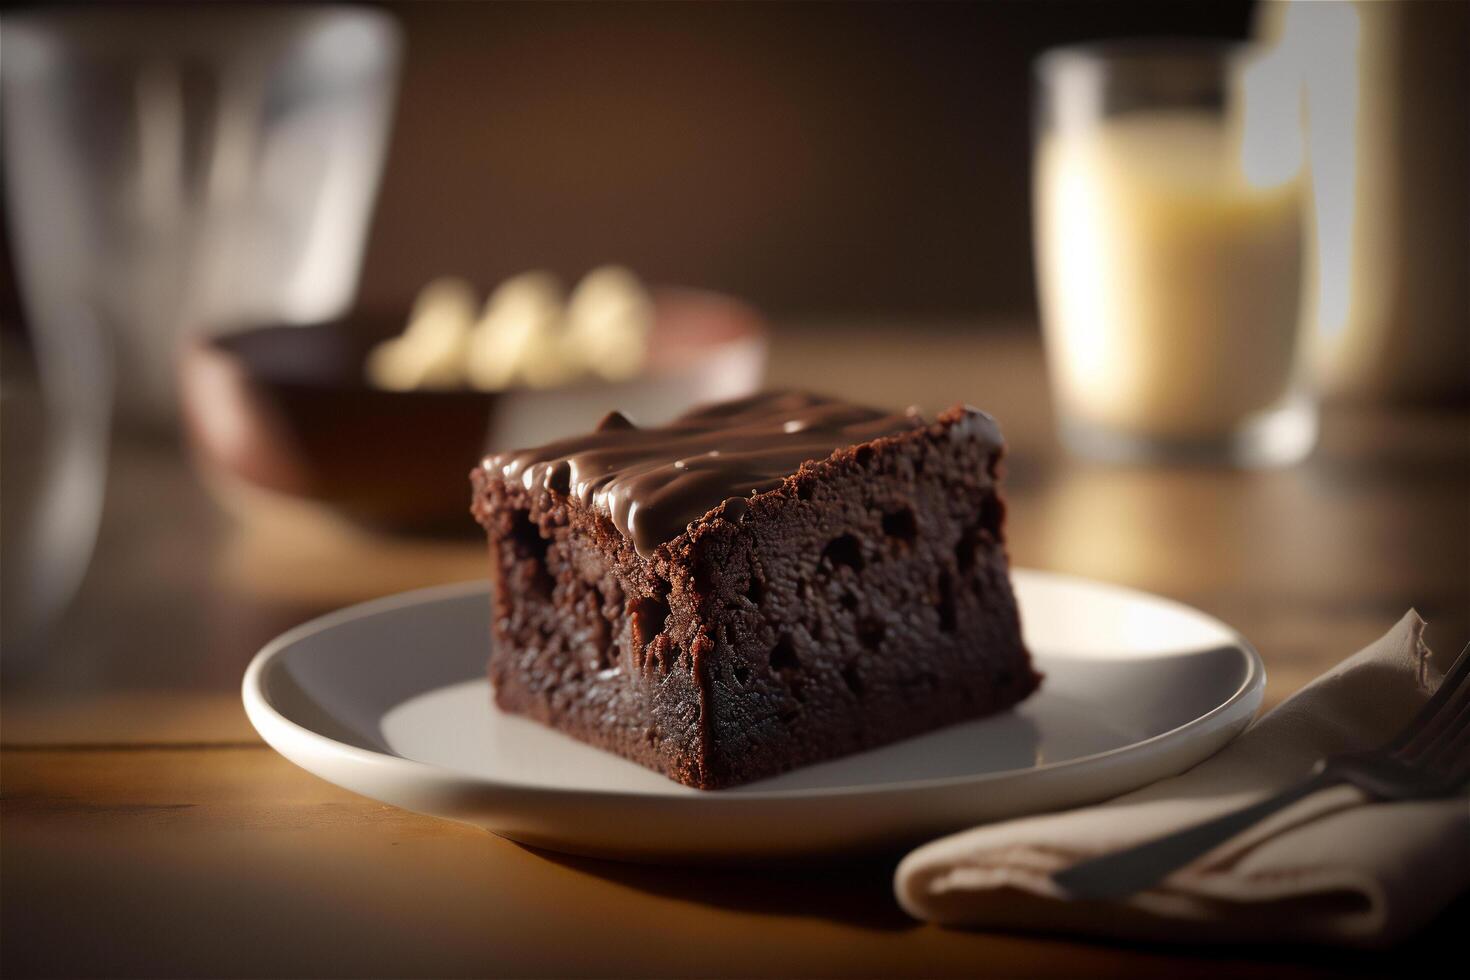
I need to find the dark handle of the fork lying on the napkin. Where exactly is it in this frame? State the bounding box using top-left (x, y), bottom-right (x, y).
top-left (1051, 767), bottom-right (1339, 901)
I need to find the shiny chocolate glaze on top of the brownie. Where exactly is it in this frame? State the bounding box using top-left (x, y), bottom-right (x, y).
top-left (482, 391), bottom-right (1001, 558)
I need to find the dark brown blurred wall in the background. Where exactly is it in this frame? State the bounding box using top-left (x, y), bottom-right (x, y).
top-left (0, 0), bottom-right (1251, 332)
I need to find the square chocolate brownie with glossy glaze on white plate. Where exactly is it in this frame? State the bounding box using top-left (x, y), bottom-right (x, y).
top-left (470, 392), bottom-right (1039, 789)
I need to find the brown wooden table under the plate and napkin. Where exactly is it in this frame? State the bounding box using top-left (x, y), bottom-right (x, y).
top-left (0, 323), bottom-right (1470, 977)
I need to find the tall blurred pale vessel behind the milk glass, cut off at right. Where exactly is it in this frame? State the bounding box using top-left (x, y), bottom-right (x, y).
top-left (1257, 0), bottom-right (1470, 400)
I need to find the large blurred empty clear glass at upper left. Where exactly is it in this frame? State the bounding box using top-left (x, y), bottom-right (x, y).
top-left (0, 4), bottom-right (398, 423)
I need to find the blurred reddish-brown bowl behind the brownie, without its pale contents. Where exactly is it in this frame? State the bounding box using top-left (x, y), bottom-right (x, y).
top-left (179, 289), bottom-right (766, 532)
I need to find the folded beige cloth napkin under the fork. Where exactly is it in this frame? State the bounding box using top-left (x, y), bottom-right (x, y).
top-left (894, 611), bottom-right (1470, 946)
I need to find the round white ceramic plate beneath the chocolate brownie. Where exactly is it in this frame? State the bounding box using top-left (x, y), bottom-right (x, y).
top-left (244, 570), bottom-right (1266, 860)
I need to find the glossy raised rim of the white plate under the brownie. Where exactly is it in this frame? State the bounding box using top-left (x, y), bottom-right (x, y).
top-left (241, 567), bottom-right (1266, 807)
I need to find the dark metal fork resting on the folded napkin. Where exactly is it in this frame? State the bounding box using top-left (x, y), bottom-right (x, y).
top-left (1051, 646), bottom-right (1470, 901)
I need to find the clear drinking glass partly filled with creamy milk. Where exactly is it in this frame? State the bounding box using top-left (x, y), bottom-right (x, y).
top-left (1033, 41), bottom-right (1317, 466)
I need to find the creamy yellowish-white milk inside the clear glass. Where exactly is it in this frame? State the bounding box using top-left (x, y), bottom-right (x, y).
top-left (1033, 109), bottom-right (1302, 442)
